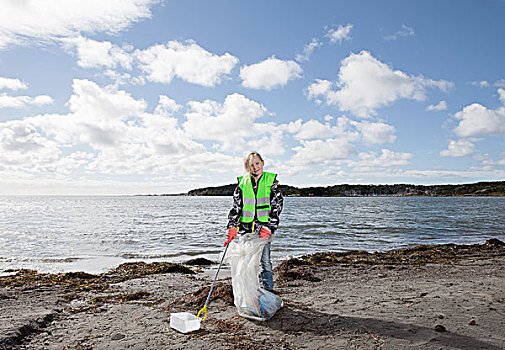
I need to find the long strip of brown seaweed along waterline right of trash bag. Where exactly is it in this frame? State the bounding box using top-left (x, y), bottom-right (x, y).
top-left (276, 238), bottom-right (505, 281)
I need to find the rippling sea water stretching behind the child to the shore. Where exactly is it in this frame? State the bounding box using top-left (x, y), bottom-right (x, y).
top-left (0, 196), bottom-right (505, 274)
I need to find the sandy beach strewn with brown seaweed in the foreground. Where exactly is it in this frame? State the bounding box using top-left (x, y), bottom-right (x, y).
top-left (0, 240), bottom-right (505, 350)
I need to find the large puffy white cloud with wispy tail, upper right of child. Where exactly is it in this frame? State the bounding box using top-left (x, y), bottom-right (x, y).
top-left (308, 51), bottom-right (453, 118)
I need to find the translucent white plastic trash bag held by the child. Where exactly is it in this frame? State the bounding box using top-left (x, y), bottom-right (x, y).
top-left (225, 233), bottom-right (282, 321)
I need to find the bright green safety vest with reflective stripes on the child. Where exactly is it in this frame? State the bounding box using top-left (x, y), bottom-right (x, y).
top-left (238, 172), bottom-right (277, 222)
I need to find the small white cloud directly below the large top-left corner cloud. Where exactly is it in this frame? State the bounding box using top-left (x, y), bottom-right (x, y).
top-left (61, 36), bottom-right (133, 69)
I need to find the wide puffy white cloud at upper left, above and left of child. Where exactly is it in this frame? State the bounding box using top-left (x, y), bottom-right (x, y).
top-left (135, 41), bottom-right (238, 86)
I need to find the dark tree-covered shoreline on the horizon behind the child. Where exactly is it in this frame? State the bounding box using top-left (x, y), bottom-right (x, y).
top-left (187, 181), bottom-right (505, 197)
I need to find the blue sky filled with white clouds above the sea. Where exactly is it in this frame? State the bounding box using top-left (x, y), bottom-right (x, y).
top-left (0, 0), bottom-right (505, 195)
